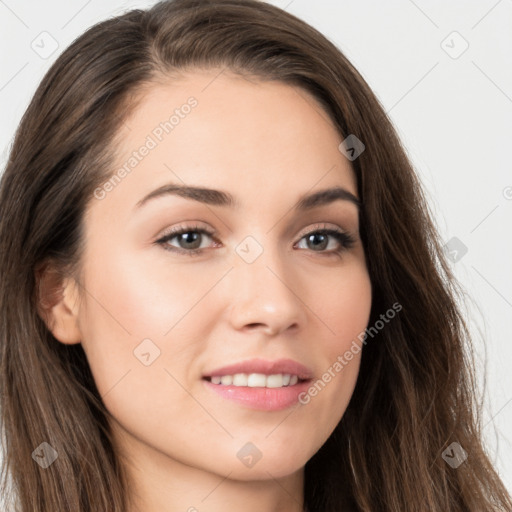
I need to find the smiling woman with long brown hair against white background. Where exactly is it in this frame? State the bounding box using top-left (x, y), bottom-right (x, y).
top-left (0, 0), bottom-right (512, 512)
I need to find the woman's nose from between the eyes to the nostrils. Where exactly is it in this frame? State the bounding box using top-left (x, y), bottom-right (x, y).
top-left (226, 235), bottom-right (304, 332)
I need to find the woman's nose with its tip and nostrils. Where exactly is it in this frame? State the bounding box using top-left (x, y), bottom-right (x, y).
top-left (229, 244), bottom-right (307, 336)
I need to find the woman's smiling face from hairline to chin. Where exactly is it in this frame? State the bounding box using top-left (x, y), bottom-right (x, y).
top-left (70, 70), bottom-right (371, 480)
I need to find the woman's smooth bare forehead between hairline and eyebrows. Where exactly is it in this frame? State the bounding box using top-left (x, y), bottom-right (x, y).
top-left (91, 69), bottom-right (357, 218)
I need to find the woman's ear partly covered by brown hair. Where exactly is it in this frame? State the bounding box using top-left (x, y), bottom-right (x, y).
top-left (35, 263), bottom-right (82, 345)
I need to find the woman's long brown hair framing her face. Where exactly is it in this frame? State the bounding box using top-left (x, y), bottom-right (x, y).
top-left (0, 0), bottom-right (512, 512)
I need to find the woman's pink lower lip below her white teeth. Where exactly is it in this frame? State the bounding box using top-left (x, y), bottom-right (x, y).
top-left (204, 380), bottom-right (309, 411)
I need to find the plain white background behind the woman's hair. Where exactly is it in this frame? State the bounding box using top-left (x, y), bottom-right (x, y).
top-left (0, 0), bottom-right (512, 498)
